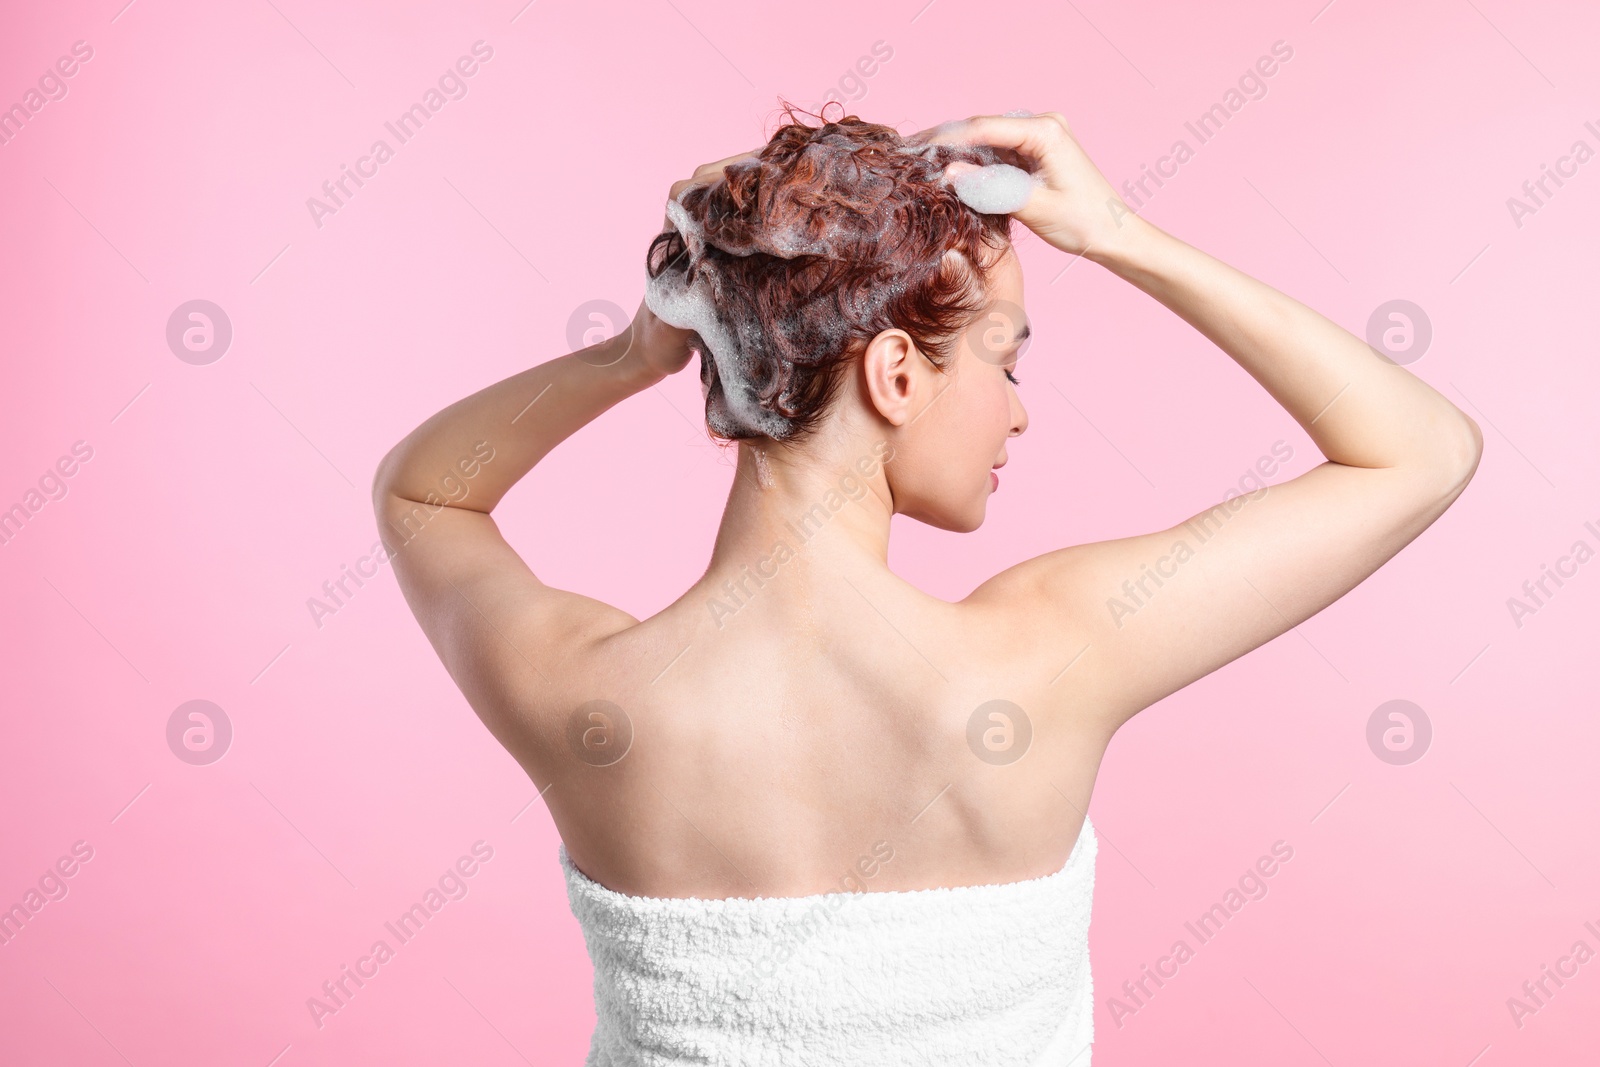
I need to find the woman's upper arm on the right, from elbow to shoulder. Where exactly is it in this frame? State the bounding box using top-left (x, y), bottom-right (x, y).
top-left (968, 427), bottom-right (1478, 729)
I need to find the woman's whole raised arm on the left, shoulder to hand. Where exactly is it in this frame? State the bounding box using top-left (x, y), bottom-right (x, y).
top-left (373, 306), bottom-right (688, 755)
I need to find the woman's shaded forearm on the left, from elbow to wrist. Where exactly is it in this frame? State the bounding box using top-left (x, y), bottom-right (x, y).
top-left (373, 330), bottom-right (664, 514)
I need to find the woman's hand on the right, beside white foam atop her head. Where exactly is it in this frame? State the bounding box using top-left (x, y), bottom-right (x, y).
top-left (907, 110), bottom-right (1138, 256)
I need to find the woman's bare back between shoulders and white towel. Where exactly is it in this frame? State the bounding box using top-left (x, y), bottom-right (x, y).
top-left (530, 560), bottom-right (1107, 897)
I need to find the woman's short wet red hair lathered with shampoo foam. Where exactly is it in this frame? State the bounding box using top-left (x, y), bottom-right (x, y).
top-left (646, 102), bottom-right (1011, 440)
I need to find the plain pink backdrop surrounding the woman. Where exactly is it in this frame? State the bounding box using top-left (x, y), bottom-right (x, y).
top-left (0, 0), bottom-right (1600, 1067)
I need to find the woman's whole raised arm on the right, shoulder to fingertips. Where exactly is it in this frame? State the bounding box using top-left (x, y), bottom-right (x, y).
top-left (946, 114), bottom-right (1483, 728)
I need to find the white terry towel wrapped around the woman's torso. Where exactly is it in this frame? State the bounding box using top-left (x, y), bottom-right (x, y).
top-left (557, 819), bottom-right (1098, 1067)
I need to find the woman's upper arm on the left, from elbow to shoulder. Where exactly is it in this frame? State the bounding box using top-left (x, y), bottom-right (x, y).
top-left (373, 486), bottom-right (637, 757)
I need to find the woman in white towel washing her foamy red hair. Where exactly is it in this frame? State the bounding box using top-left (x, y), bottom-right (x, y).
top-left (374, 112), bottom-right (1482, 1065)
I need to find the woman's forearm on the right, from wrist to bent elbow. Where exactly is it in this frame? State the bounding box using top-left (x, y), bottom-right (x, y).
top-left (1088, 216), bottom-right (1480, 474)
